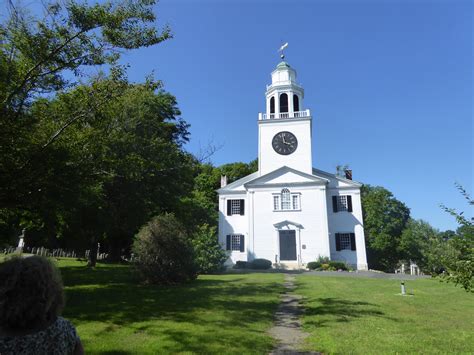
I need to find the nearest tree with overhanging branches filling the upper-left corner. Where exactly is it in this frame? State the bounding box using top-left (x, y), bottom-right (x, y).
top-left (0, 0), bottom-right (171, 214)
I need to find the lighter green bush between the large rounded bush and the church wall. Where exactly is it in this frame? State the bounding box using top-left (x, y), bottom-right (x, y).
top-left (193, 224), bottom-right (227, 274)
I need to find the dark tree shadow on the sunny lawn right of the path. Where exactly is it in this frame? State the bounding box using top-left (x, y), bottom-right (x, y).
top-left (304, 297), bottom-right (397, 327)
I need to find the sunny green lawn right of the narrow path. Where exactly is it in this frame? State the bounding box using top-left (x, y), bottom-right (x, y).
top-left (295, 275), bottom-right (474, 354)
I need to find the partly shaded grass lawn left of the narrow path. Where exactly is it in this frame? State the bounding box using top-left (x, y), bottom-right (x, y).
top-left (58, 259), bottom-right (283, 354)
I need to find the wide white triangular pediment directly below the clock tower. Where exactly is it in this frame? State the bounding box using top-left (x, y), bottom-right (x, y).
top-left (244, 166), bottom-right (328, 188)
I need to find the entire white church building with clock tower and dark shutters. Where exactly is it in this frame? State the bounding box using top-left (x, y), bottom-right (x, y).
top-left (218, 61), bottom-right (367, 270)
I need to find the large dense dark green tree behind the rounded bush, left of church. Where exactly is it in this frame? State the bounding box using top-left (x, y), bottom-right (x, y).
top-left (33, 77), bottom-right (193, 259)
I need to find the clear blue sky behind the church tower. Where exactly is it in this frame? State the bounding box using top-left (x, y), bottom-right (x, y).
top-left (123, 0), bottom-right (473, 230)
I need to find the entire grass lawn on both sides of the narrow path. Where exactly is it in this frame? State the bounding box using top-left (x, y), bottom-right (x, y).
top-left (0, 256), bottom-right (474, 354)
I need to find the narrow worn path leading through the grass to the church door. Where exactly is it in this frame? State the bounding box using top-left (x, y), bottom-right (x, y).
top-left (270, 274), bottom-right (319, 355)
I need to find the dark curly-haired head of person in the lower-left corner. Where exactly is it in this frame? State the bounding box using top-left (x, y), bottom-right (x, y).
top-left (0, 256), bottom-right (64, 330)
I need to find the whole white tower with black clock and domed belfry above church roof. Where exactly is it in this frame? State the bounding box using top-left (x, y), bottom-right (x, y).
top-left (258, 61), bottom-right (312, 176)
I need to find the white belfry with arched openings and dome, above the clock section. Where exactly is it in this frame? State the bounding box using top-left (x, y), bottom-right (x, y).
top-left (259, 61), bottom-right (310, 120)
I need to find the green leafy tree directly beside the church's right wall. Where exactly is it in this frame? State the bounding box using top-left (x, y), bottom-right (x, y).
top-left (361, 185), bottom-right (410, 271)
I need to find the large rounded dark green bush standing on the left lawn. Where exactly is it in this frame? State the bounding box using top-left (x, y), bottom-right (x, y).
top-left (132, 214), bottom-right (197, 285)
